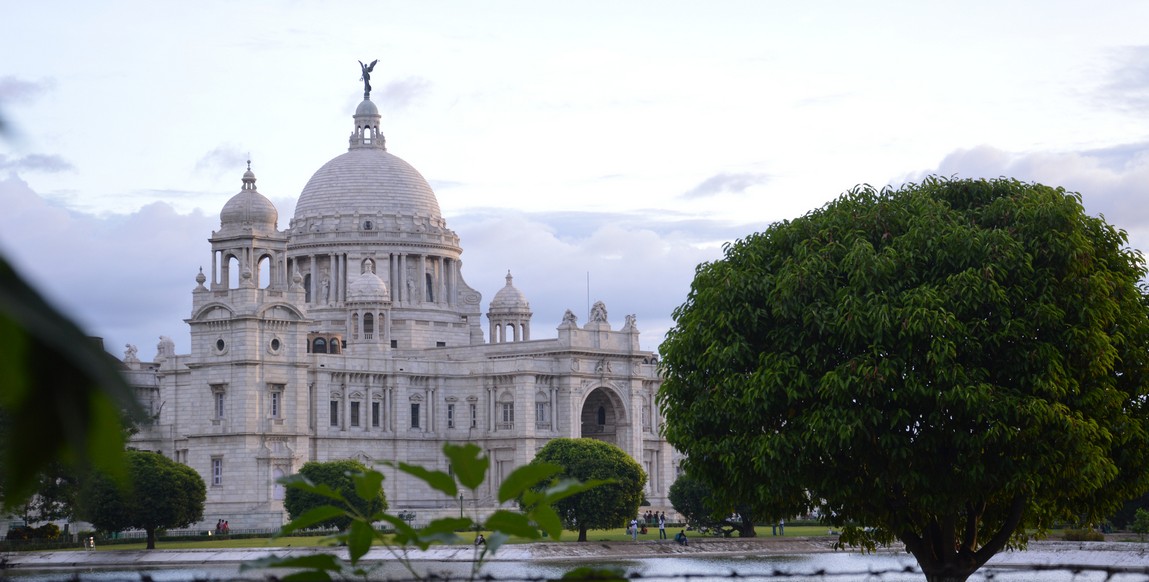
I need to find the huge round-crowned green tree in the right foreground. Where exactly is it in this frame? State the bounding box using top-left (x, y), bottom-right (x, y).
top-left (658, 178), bottom-right (1149, 580)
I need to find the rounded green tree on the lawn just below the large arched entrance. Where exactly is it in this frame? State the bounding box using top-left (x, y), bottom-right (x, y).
top-left (531, 439), bottom-right (647, 542)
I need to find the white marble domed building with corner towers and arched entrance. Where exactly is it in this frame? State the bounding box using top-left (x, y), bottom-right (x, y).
top-left (124, 87), bottom-right (673, 530)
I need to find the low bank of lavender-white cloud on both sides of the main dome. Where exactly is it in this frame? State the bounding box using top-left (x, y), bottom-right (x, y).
top-left (0, 177), bottom-right (731, 357)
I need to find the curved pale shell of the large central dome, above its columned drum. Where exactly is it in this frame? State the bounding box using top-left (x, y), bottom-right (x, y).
top-left (295, 147), bottom-right (441, 219)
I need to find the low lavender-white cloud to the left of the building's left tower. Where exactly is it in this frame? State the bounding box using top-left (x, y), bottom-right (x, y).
top-left (0, 177), bottom-right (217, 356)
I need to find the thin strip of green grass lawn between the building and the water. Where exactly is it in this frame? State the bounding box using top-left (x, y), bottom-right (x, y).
top-left (97, 526), bottom-right (827, 551)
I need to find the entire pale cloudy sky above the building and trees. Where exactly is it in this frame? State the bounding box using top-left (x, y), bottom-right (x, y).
top-left (0, 0), bottom-right (1149, 357)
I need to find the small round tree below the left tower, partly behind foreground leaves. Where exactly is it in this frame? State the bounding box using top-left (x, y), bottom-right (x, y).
top-left (284, 459), bottom-right (387, 530)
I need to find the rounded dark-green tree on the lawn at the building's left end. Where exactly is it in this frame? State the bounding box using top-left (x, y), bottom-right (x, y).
top-left (79, 451), bottom-right (207, 550)
